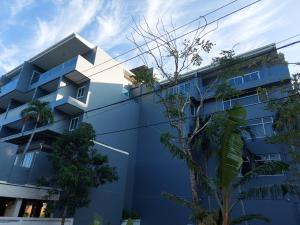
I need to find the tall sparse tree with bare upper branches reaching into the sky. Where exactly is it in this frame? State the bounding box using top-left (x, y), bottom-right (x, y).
top-left (131, 17), bottom-right (213, 225)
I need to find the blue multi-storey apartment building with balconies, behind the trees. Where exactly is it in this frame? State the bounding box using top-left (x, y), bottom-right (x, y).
top-left (0, 34), bottom-right (300, 225)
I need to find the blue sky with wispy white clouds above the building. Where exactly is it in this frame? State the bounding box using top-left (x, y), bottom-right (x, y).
top-left (0, 0), bottom-right (300, 74)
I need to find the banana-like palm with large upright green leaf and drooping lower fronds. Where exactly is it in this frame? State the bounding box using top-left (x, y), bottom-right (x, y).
top-left (163, 106), bottom-right (300, 225)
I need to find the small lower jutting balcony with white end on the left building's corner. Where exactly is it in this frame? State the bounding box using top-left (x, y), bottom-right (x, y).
top-left (53, 96), bottom-right (87, 116)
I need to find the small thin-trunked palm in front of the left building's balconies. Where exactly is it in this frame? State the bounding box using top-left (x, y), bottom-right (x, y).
top-left (21, 100), bottom-right (54, 155)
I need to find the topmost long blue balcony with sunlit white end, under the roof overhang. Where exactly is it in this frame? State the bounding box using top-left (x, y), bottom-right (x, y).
top-left (29, 55), bottom-right (92, 89)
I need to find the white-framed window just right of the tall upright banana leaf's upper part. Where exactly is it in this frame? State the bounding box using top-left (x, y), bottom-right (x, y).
top-left (243, 117), bottom-right (274, 139)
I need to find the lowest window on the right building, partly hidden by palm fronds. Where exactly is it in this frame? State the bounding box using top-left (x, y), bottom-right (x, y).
top-left (240, 153), bottom-right (283, 176)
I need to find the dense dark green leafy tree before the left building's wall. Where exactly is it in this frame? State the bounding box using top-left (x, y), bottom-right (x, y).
top-left (49, 123), bottom-right (118, 225)
